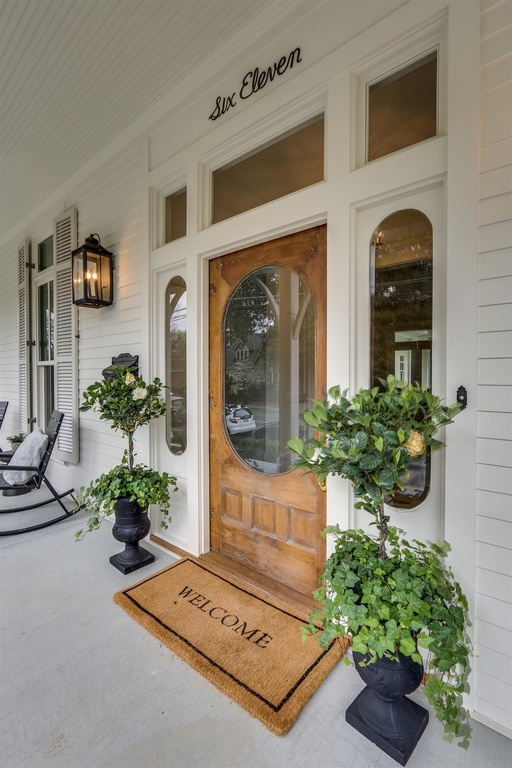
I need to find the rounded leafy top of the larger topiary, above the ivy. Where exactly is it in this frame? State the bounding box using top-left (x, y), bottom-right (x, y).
top-left (288, 376), bottom-right (460, 557)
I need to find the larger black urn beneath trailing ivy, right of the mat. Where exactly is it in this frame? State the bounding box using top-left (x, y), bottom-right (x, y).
top-left (346, 652), bottom-right (428, 765)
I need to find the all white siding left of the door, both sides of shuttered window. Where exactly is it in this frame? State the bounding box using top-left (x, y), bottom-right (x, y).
top-left (0, 141), bottom-right (145, 492)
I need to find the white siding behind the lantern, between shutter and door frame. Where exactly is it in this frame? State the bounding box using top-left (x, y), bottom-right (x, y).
top-left (77, 142), bottom-right (148, 488)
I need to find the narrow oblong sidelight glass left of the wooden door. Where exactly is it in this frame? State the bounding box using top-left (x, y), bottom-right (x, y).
top-left (165, 276), bottom-right (187, 456)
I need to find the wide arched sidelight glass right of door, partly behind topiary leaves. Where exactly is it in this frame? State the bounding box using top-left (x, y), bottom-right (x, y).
top-left (370, 209), bottom-right (433, 509)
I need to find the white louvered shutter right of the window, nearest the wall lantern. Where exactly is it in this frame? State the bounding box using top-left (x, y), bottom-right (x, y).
top-left (53, 208), bottom-right (79, 464)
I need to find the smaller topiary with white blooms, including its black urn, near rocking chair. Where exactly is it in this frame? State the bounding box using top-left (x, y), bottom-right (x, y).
top-left (76, 369), bottom-right (176, 573)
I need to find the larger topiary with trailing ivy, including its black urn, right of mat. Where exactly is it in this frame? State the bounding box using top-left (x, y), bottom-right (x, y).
top-left (288, 376), bottom-right (471, 765)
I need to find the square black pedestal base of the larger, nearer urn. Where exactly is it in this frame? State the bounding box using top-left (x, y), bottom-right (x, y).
top-left (345, 686), bottom-right (428, 765)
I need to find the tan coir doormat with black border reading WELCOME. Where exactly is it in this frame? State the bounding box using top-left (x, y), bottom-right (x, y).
top-left (114, 558), bottom-right (343, 735)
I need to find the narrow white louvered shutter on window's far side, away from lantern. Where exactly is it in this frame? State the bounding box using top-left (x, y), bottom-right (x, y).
top-left (18, 240), bottom-right (32, 432)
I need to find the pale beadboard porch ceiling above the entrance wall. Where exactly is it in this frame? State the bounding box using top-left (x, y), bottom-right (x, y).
top-left (0, 0), bottom-right (406, 241)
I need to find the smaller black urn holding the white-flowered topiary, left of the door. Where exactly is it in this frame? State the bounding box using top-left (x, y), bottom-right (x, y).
top-left (110, 498), bottom-right (155, 575)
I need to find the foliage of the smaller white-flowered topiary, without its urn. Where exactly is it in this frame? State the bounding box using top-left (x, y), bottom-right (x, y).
top-left (76, 369), bottom-right (176, 540)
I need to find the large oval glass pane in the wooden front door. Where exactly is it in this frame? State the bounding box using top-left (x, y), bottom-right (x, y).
top-left (224, 266), bottom-right (315, 475)
